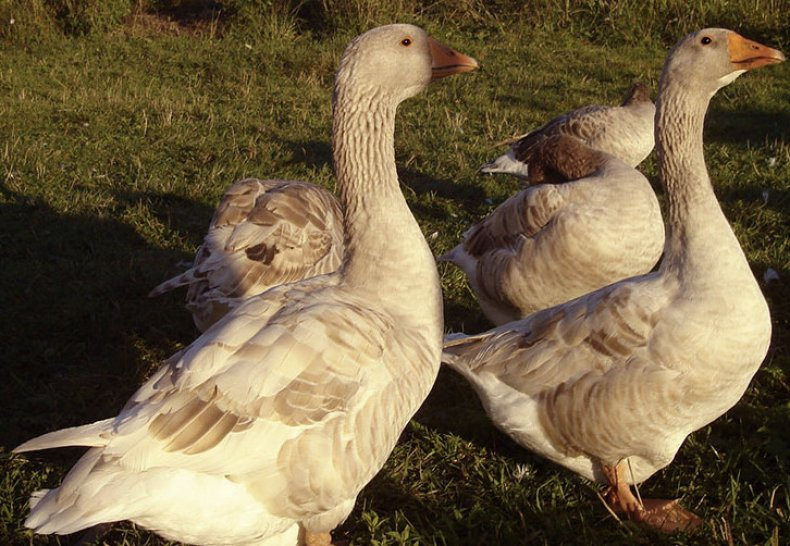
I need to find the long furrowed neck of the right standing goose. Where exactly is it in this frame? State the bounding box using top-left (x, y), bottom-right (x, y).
top-left (656, 74), bottom-right (752, 281)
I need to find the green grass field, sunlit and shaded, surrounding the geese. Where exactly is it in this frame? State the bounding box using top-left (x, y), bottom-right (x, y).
top-left (0, 4), bottom-right (790, 546)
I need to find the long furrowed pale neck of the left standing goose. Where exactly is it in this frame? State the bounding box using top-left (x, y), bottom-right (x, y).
top-left (332, 78), bottom-right (441, 316)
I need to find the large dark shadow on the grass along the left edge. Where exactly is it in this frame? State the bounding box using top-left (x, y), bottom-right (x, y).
top-left (0, 184), bottom-right (204, 448)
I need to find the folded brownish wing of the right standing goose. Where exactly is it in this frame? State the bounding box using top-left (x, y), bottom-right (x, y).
top-left (443, 276), bottom-right (671, 397)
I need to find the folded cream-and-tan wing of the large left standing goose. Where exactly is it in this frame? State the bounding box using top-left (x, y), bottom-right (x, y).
top-left (108, 284), bottom-right (391, 471)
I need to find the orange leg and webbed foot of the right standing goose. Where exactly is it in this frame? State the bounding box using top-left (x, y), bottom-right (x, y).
top-left (602, 461), bottom-right (702, 533)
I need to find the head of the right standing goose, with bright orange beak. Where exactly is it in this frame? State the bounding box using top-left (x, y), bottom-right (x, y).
top-left (664, 28), bottom-right (785, 96)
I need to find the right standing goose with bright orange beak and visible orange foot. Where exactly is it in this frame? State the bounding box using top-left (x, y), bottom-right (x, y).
top-left (443, 28), bottom-right (785, 531)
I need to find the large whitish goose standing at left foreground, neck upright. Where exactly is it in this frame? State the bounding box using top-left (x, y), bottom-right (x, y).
top-left (15, 25), bottom-right (478, 546)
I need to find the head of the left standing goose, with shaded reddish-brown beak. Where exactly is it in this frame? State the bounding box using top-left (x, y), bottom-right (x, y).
top-left (335, 24), bottom-right (479, 103)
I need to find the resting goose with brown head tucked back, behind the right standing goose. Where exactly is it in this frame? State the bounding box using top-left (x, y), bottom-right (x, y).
top-left (439, 135), bottom-right (664, 325)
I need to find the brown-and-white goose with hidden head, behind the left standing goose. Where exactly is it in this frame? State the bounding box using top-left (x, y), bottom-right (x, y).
top-left (148, 178), bottom-right (344, 332)
